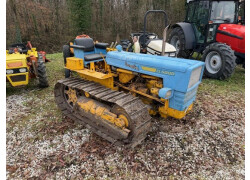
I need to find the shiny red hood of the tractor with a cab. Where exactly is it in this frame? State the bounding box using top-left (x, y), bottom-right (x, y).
top-left (216, 24), bottom-right (245, 53)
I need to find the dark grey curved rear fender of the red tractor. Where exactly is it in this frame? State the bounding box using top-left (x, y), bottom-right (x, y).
top-left (172, 22), bottom-right (196, 49)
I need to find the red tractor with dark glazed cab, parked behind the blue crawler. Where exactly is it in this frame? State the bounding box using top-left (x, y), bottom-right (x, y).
top-left (168, 0), bottom-right (245, 80)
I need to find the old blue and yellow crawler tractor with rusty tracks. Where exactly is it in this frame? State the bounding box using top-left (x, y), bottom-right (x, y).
top-left (54, 38), bottom-right (204, 147)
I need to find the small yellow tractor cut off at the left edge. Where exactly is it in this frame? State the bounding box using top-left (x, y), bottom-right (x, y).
top-left (6, 42), bottom-right (49, 88)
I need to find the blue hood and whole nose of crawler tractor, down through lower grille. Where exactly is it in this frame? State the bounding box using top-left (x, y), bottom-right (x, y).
top-left (106, 51), bottom-right (204, 111)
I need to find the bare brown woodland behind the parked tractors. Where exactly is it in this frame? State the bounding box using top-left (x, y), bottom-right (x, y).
top-left (6, 0), bottom-right (244, 53)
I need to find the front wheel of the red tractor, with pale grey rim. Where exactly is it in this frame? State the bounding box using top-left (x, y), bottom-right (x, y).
top-left (202, 42), bottom-right (236, 80)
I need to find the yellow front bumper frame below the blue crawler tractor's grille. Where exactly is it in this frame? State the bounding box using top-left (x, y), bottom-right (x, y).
top-left (159, 100), bottom-right (193, 119)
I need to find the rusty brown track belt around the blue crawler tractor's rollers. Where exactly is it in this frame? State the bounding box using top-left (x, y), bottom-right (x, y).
top-left (54, 78), bottom-right (151, 148)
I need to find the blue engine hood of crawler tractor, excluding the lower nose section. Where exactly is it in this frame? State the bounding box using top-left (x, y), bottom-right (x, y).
top-left (106, 51), bottom-right (204, 92)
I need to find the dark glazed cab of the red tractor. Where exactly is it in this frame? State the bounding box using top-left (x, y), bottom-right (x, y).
top-left (184, 0), bottom-right (239, 44)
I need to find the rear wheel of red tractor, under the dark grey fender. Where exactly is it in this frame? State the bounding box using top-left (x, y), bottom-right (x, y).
top-left (168, 27), bottom-right (192, 59)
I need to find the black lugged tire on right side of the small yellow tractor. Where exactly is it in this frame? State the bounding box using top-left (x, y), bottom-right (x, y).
top-left (37, 53), bottom-right (49, 88)
